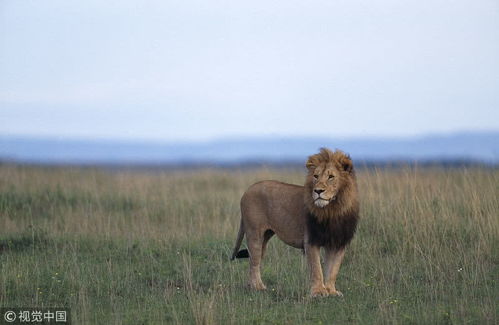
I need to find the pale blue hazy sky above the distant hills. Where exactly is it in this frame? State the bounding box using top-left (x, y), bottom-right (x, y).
top-left (0, 0), bottom-right (499, 141)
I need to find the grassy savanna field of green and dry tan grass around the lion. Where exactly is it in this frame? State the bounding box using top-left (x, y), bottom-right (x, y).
top-left (0, 165), bottom-right (499, 324)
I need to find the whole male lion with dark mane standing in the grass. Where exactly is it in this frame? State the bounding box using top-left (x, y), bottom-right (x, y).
top-left (232, 148), bottom-right (359, 297)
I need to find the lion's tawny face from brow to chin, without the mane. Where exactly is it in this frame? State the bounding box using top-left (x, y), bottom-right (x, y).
top-left (311, 164), bottom-right (341, 208)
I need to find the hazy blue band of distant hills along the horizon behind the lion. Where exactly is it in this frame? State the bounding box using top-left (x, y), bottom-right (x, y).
top-left (0, 132), bottom-right (499, 165)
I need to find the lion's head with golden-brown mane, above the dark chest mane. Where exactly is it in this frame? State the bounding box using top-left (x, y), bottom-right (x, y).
top-left (305, 148), bottom-right (357, 217)
